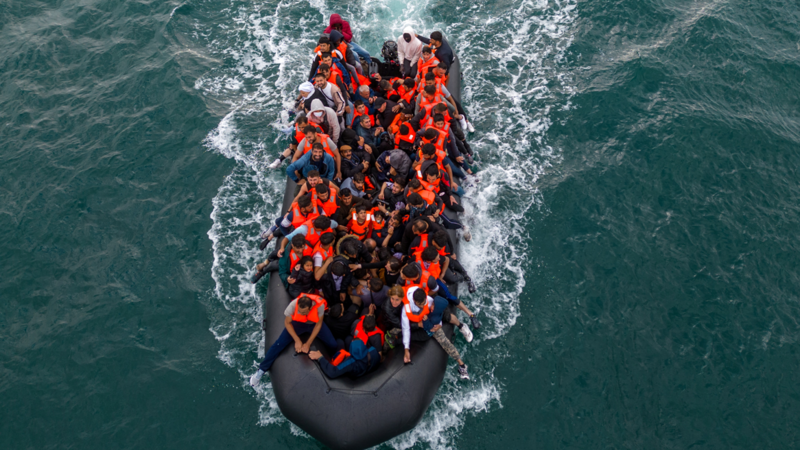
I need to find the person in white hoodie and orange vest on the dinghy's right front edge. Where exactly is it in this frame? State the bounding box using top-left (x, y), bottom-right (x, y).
top-left (400, 286), bottom-right (472, 380)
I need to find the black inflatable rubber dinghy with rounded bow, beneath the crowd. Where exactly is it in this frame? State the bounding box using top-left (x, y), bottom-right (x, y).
top-left (264, 53), bottom-right (461, 449)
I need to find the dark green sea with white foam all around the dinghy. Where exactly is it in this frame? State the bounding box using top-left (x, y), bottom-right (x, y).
top-left (0, 0), bottom-right (800, 450)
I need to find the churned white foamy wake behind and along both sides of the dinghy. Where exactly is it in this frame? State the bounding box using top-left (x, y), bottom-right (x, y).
top-left (185, 0), bottom-right (577, 449)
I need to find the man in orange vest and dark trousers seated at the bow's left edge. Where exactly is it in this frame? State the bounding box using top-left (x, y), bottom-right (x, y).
top-left (250, 294), bottom-right (338, 387)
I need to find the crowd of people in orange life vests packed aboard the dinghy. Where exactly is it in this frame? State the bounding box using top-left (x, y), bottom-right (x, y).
top-left (250, 14), bottom-right (481, 386)
